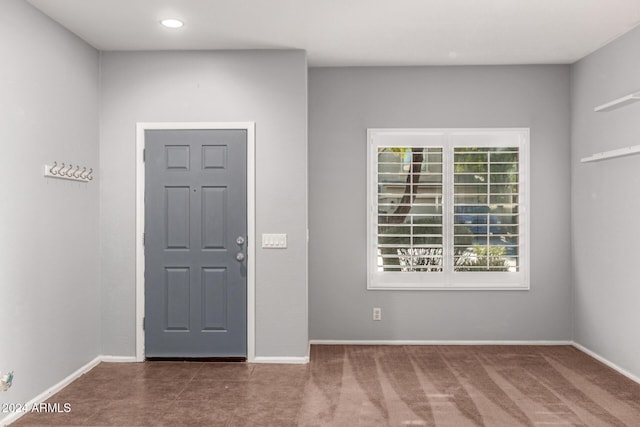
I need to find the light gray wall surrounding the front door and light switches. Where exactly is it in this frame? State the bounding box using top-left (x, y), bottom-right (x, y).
top-left (100, 51), bottom-right (308, 357)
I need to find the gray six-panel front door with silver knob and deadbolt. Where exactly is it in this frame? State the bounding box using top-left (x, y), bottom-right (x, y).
top-left (145, 129), bottom-right (247, 357)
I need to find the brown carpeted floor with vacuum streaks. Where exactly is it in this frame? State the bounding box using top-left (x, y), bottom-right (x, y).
top-left (15, 345), bottom-right (640, 427)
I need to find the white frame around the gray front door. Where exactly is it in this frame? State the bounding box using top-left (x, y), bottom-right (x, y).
top-left (136, 122), bottom-right (256, 362)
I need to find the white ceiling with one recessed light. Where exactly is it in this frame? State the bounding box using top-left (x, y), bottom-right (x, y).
top-left (29, 0), bottom-right (640, 66)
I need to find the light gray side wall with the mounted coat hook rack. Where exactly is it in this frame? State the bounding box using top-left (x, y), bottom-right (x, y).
top-left (0, 0), bottom-right (100, 419)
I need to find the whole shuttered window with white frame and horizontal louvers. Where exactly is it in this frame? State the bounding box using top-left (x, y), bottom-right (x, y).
top-left (367, 129), bottom-right (529, 289)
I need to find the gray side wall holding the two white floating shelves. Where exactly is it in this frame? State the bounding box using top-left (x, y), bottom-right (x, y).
top-left (571, 28), bottom-right (640, 377)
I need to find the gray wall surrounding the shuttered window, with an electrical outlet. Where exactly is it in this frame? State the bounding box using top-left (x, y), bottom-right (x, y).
top-left (309, 66), bottom-right (572, 340)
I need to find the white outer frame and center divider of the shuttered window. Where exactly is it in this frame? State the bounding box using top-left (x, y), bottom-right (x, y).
top-left (367, 128), bottom-right (530, 290)
